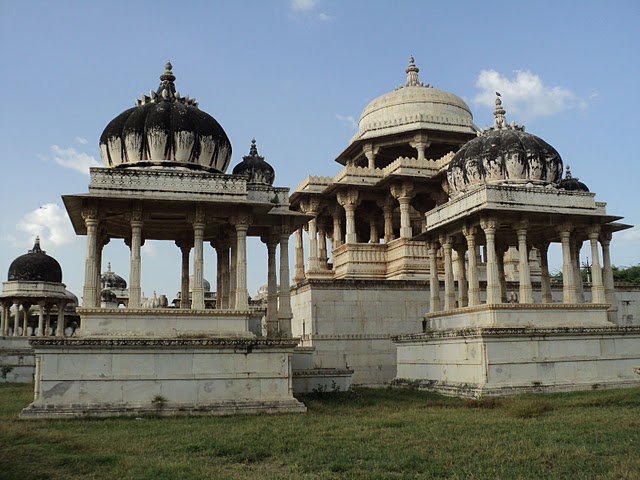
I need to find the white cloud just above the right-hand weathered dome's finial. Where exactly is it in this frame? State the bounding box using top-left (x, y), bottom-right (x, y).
top-left (473, 70), bottom-right (597, 123)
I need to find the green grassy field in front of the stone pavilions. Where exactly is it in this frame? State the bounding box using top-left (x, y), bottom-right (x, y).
top-left (0, 384), bottom-right (640, 480)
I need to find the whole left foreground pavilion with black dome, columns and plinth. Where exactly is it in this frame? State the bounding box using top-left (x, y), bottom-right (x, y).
top-left (22, 63), bottom-right (308, 418)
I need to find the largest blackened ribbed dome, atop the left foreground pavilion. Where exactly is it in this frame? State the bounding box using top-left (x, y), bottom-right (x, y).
top-left (100, 63), bottom-right (231, 172)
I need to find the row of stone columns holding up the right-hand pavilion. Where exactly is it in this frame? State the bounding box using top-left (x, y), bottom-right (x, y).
top-left (428, 218), bottom-right (616, 314)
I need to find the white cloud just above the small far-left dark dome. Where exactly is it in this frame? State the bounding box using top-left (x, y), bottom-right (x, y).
top-left (16, 203), bottom-right (76, 250)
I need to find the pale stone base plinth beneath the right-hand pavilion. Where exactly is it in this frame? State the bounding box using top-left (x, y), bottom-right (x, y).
top-left (393, 326), bottom-right (640, 396)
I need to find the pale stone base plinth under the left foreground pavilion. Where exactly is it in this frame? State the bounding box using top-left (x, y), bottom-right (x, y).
top-left (20, 337), bottom-right (306, 419)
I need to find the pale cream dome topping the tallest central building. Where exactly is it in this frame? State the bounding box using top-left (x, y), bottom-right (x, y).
top-left (352, 57), bottom-right (476, 141)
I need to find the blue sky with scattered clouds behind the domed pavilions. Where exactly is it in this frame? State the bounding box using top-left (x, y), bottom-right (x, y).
top-left (0, 0), bottom-right (640, 298)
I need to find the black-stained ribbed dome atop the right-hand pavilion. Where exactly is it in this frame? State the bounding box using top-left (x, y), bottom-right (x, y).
top-left (447, 98), bottom-right (562, 195)
